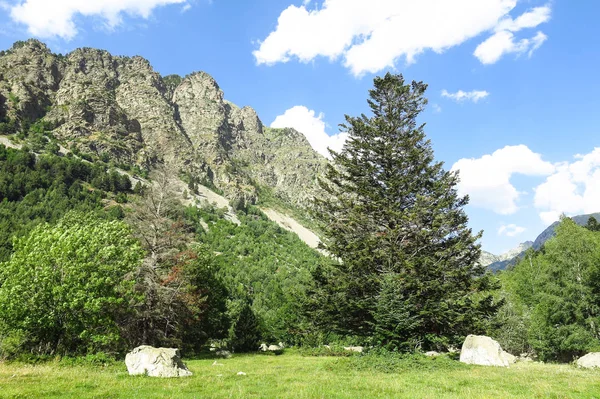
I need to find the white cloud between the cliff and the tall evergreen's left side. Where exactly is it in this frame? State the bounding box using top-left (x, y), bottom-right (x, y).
top-left (271, 105), bottom-right (348, 158)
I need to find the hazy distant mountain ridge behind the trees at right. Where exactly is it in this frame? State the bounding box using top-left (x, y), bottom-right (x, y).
top-left (479, 213), bottom-right (600, 271)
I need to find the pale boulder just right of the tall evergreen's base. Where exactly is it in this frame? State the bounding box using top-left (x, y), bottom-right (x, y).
top-left (460, 335), bottom-right (516, 367)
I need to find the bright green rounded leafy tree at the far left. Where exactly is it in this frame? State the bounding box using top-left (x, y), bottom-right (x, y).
top-left (0, 212), bottom-right (143, 354)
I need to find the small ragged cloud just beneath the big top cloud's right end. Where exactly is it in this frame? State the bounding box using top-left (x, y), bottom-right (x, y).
top-left (474, 30), bottom-right (548, 64)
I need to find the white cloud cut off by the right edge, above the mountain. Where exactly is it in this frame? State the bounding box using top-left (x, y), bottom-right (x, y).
top-left (534, 147), bottom-right (600, 224)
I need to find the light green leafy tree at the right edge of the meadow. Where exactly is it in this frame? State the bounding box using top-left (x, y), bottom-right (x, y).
top-left (505, 217), bottom-right (600, 361)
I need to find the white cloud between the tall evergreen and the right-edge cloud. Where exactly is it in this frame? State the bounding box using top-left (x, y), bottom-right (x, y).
top-left (452, 145), bottom-right (555, 215)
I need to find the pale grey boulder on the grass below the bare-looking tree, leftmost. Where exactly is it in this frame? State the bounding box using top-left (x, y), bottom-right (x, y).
top-left (125, 345), bottom-right (192, 378)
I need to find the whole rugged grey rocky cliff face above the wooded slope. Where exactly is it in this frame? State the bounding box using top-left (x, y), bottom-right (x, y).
top-left (0, 40), bottom-right (327, 206)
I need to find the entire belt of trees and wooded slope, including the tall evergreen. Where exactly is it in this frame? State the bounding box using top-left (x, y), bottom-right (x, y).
top-left (0, 74), bottom-right (600, 362)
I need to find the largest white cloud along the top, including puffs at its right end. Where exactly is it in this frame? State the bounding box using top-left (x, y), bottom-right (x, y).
top-left (254, 0), bottom-right (550, 75)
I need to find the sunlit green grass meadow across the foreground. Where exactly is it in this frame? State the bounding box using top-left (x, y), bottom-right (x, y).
top-left (0, 353), bottom-right (600, 399)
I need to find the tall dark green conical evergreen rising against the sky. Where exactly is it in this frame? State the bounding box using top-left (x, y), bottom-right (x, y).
top-left (309, 73), bottom-right (500, 350)
